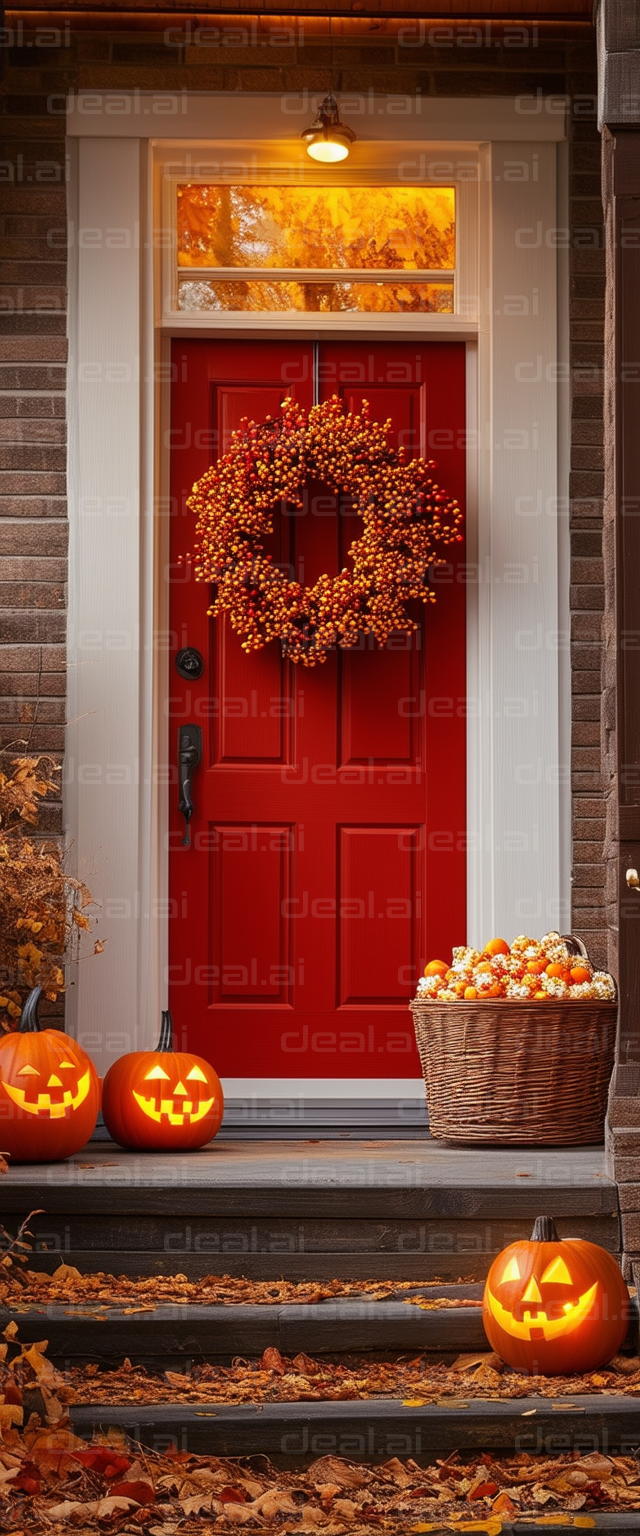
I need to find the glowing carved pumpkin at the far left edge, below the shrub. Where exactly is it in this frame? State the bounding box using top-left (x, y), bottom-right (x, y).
top-left (0, 986), bottom-right (100, 1163)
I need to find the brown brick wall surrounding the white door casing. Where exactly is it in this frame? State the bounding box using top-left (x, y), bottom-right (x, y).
top-left (0, 17), bottom-right (606, 962)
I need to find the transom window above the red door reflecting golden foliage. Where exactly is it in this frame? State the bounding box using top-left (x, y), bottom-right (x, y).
top-left (176, 181), bottom-right (456, 315)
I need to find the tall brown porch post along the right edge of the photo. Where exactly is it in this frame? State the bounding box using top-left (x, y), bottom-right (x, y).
top-left (597, 0), bottom-right (640, 1281)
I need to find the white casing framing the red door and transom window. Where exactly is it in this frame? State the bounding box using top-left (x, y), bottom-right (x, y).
top-left (66, 92), bottom-right (571, 1118)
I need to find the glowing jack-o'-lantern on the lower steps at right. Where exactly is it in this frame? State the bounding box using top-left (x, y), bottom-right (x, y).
top-left (482, 1217), bottom-right (629, 1376)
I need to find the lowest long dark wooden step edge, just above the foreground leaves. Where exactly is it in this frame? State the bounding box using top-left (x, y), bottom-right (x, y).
top-left (65, 1395), bottom-right (640, 1462)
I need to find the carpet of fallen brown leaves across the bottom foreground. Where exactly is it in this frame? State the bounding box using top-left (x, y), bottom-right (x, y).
top-left (0, 1430), bottom-right (640, 1536)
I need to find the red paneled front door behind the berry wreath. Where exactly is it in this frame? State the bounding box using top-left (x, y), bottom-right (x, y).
top-left (167, 341), bottom-right (467, 1078)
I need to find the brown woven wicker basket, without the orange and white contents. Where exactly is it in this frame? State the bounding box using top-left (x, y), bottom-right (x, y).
top-left (410, 946), bottom-right (617, 1146)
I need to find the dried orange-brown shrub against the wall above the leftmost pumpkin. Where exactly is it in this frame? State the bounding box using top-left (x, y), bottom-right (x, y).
top-left (0, 757), bottom-right (103, 1031)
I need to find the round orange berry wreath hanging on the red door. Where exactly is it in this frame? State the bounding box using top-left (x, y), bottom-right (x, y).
top-left (187, 395), bottom-right (462, 667)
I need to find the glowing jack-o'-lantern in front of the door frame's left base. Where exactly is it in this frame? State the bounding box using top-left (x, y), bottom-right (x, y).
top-left (103, 1012), bottom-right (224, 1152)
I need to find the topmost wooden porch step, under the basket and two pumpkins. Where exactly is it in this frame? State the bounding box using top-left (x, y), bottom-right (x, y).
top-left (2, 1137), bottom-right (620, 1283)
